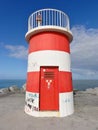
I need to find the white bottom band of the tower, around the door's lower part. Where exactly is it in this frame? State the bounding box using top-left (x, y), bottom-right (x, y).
top-left (25, 92), bottom-right (74, 117)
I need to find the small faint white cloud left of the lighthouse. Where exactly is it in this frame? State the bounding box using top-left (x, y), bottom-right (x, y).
top-left (5, 45), bottom-right (28, 59)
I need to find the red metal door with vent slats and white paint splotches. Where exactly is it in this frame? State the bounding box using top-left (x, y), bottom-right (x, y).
top-left (40, 67), bottom-right (59, 111)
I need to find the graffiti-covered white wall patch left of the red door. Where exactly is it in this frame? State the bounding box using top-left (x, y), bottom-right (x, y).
top-left (26, 92), bottom-right (39, 112)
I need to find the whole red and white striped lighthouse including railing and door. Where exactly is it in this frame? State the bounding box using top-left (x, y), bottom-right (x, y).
top-left (25, 9), bottom-right (74, 117)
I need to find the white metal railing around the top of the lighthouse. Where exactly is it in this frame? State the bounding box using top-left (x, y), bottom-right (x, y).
top-left (28, 9), bottom-right (70, 31)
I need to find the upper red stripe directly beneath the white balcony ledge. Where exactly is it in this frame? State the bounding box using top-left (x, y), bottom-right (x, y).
top-left (29, 32), bottom-right (70, 53)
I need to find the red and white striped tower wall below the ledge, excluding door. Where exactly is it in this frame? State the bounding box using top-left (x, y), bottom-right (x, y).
top-left (25, 32), bottom-right (74, 117)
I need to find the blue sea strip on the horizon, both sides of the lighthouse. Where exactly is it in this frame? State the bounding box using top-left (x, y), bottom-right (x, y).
top-left (0, 79), bottom-right (98, 90)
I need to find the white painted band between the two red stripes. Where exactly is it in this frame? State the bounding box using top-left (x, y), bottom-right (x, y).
top-left (28, 50), bottom-right (71, 72)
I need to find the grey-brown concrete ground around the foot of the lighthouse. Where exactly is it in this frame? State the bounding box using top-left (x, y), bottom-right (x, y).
top-left (0, 88), bottom-right (98, 130)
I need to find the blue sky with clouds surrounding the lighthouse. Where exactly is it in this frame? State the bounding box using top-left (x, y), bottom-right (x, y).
top-left (0, 0), bottom-right (98, 79)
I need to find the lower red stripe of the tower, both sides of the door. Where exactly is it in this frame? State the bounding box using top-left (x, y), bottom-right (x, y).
top-left (26, 71), bottom-right (73, 93)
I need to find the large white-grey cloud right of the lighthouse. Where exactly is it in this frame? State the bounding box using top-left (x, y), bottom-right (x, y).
top-left (71, 26), bottom-right (98, 77)
